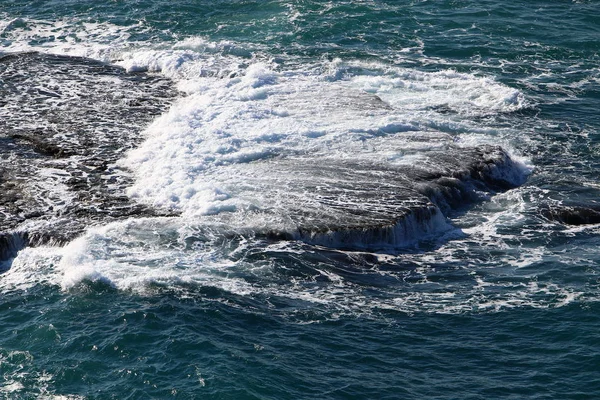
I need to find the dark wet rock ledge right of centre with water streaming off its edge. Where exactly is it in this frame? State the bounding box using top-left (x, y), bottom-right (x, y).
top-left (213, 146), bottom-right (525, 249)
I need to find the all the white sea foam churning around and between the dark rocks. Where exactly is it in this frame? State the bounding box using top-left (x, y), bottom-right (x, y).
top-left (0, 19), bottom-right (556, 312)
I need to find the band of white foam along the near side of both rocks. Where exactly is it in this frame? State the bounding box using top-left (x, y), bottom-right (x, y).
top-left (0, 209), bottom-right (586, 316)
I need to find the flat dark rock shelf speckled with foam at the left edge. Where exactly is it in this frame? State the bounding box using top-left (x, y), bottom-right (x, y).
top-left (0, 53), bottom-right (177, 259)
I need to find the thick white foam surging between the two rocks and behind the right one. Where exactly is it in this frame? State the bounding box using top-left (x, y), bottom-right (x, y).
top-left (116, 52), bottom-right (527, 219)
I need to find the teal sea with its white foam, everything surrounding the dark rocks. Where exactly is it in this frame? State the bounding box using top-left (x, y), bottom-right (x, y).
top-left (0, 0), bottom-right (600, 399)
